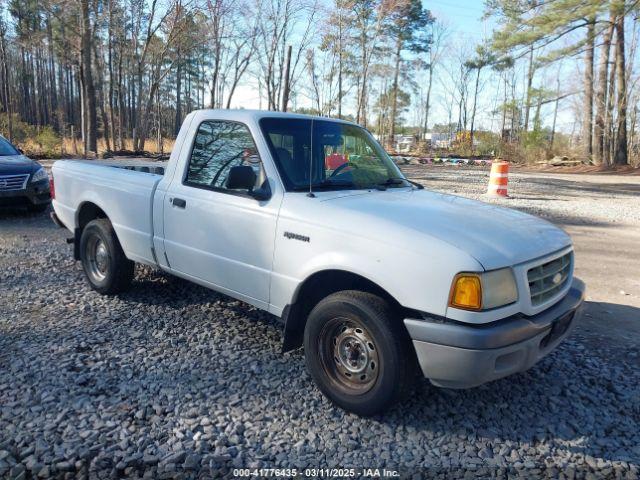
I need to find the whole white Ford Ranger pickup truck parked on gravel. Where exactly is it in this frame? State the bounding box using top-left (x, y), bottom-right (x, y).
top-left (53, 110), bottom-right (584, 415)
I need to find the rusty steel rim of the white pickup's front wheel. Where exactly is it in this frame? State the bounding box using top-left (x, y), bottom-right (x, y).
top-left (319, 317), bottom-right (380, 395)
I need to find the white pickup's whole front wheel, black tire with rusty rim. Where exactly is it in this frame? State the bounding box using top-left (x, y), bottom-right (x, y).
top-left (304, 290), bottom-right (416, 416)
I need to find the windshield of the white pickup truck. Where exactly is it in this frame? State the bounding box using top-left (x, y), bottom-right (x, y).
top-left (260, 118), bottom-right (409, 191)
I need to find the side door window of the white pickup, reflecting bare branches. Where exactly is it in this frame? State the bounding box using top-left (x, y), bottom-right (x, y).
top-left (185, 120), bottom-right (265, 192)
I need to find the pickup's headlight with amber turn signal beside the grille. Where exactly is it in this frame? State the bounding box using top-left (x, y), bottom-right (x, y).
top-left (449, 268), bottom-right (518, 310)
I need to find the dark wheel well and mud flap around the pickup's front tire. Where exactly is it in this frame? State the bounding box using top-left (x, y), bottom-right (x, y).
top-left (282, 270), bottom-right (403, 352)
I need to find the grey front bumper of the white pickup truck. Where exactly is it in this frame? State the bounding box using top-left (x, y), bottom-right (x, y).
top-left (404, 278), bottom-right (585, 388)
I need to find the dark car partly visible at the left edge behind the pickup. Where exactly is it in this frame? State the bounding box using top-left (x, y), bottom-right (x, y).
top-left (0, 136), bottom-right (51, 212)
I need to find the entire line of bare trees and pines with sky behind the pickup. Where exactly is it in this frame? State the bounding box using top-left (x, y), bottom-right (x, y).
top-left (0, 0), bottom-right (638, 165)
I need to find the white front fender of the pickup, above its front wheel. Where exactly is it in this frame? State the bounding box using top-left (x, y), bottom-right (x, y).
top-left (271, 231), bottom-right (482, 316)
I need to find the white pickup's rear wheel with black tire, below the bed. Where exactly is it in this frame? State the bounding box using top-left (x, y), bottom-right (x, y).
top-left (80, 218), bottom-right (135, 295)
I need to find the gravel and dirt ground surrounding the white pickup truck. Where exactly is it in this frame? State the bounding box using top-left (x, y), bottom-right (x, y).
top-left (0, 166), bottom-right (640, 478)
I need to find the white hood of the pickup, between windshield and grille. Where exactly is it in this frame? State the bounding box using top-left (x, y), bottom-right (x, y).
top-left (326, 189), bottom-right (571, 270)
